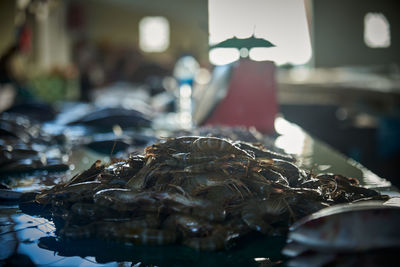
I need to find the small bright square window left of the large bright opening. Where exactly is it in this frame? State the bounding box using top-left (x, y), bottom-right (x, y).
top-left (139, 17), bottom-right (169, 52)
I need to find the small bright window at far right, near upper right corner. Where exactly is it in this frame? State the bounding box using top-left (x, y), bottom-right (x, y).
top-left (364, 13), bottom-right (390, 48)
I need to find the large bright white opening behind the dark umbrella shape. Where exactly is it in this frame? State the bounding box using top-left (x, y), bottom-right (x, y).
top-left (208, 0), bottom-right (312, 65)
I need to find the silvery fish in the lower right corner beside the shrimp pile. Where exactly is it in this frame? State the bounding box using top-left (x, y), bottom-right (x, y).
top-left (282, 202), bottom-right (400, 266)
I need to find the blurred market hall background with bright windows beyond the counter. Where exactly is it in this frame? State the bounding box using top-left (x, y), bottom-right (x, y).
top-left (0, 0), bottom-right (400, 185)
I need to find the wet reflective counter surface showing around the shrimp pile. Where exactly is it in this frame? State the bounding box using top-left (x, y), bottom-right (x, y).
top-left (0, 118), bottom-right (399, 266)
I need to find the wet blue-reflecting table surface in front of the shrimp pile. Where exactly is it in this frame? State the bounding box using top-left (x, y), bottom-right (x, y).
top-left (0, 206), bottom-right (285, 266)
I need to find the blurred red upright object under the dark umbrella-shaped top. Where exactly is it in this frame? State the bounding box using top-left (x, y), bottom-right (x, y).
top-left (205, 59), bottom-right (278, 133)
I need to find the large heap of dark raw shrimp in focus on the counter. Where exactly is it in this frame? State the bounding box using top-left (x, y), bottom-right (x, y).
top-left (32, 136), bottom-right (387, 251)
